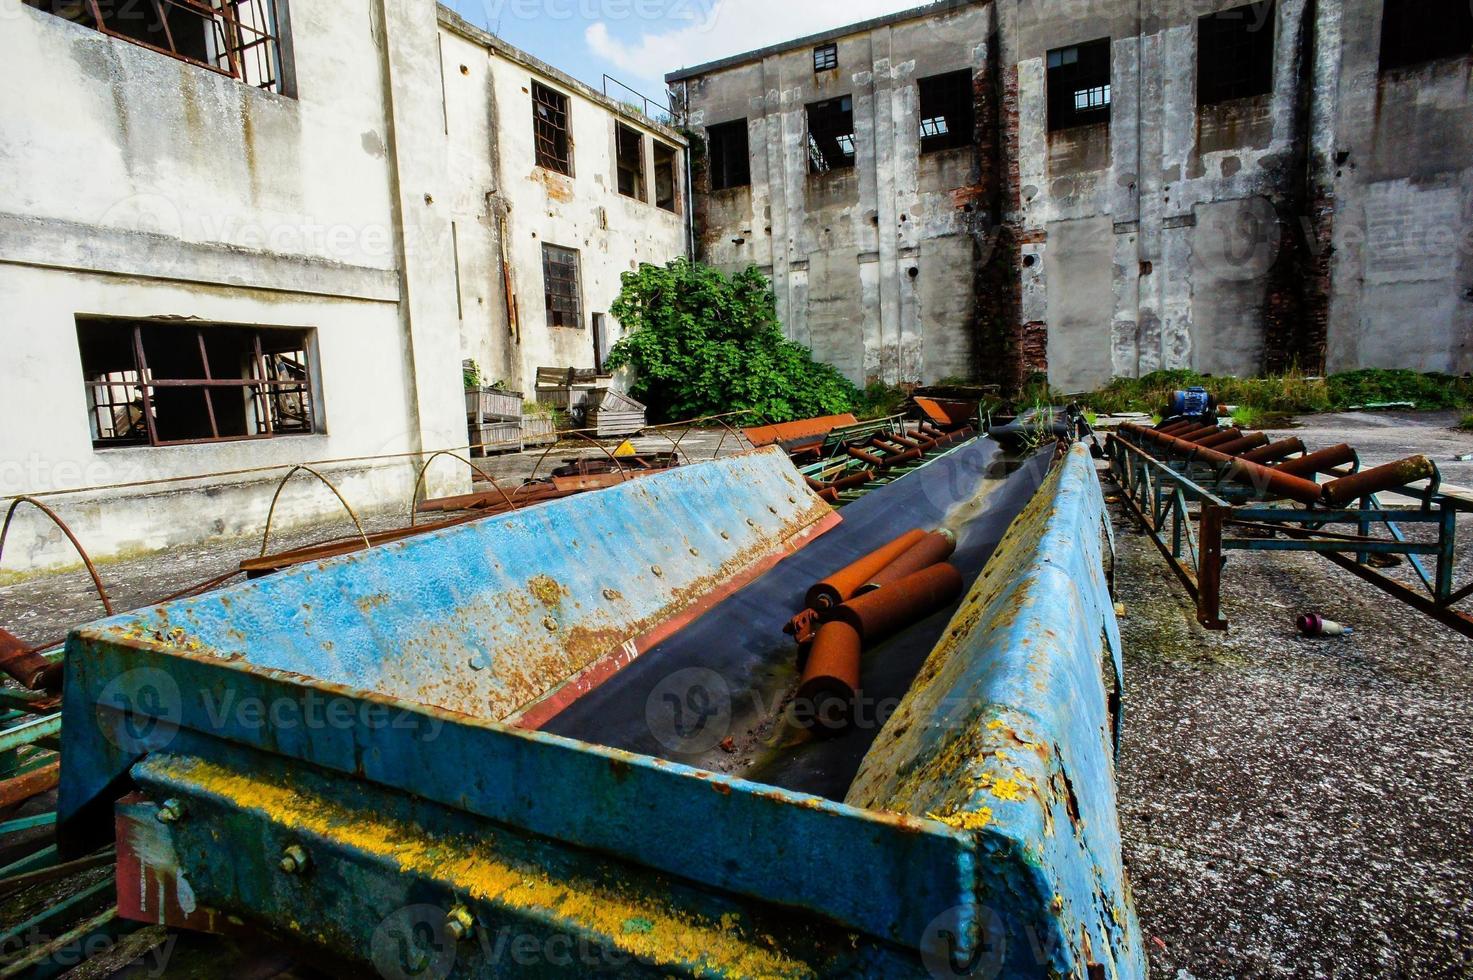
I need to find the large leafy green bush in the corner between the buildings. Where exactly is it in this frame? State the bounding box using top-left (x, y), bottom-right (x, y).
top-left (607, 259), bottom-right (859, 421)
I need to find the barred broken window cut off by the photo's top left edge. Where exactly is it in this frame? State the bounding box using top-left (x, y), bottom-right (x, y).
top-left (25, 0), bottom-right (283, 93)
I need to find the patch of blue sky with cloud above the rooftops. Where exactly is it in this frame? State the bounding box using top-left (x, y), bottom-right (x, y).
top-left (445, 0), bottom-right (925, 112)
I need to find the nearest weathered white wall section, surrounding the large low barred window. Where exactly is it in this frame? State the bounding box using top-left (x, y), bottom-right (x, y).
top-left (0, 0), bottom-right (465, 572)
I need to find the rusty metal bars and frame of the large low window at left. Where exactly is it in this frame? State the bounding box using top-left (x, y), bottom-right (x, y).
top-left (77, 317), bottom-right (318, 449)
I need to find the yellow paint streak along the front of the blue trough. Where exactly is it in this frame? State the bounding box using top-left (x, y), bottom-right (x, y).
top-left (169, 759), bottom-right (813, 977)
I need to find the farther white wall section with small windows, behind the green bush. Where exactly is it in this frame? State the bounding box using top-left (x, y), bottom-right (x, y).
top-left (440, 9), bottom-right (688, 399)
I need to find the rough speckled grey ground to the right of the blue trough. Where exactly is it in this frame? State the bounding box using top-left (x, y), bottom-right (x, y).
top-left (1106, 414), bottom-right (1473, 980)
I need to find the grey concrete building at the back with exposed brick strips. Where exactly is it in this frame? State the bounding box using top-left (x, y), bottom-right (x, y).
top-left (669, 0), bottom-right (1473, 391)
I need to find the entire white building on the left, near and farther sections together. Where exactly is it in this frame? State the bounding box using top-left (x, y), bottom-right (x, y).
top-left (0, 0), bottom-right (686, 575)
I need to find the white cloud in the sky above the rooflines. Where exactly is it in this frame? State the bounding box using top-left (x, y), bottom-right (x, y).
top-left (583, 0), bottom-right (924, 96)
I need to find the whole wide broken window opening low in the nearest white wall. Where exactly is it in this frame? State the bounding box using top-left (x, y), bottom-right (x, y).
top-left (77, 317), bottom-right (317, 448)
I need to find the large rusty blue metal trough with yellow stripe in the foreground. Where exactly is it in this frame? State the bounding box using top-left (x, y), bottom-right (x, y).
top-left (59, 448), bottom-right (1145, 977)
